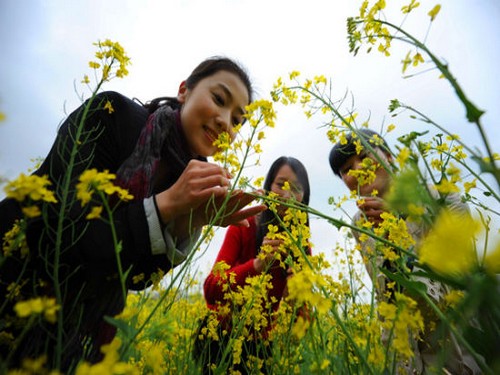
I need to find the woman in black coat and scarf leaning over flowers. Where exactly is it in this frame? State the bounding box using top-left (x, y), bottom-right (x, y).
top-left (0, 58), bottom-right (264, 369)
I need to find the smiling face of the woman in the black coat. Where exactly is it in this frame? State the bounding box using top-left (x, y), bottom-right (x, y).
top-left (177, 70), bottom-right (249, 157)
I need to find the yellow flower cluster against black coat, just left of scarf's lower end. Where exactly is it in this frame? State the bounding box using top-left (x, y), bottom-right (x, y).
top-left (76, 168), bottom-right (133, 206)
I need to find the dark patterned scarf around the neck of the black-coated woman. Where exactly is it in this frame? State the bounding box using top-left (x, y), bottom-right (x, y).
top-left (116, 105), bottom-right (206, 200)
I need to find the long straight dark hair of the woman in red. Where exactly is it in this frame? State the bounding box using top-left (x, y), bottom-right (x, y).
top-left (256, 156), bottom-right (311, 249)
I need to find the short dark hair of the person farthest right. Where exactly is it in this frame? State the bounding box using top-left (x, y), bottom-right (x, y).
top-left (328, 128), bottom-right (391, 177)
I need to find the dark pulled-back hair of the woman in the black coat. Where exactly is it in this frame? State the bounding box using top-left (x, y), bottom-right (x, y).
top-left (144, 56), bottom-right (253, 113)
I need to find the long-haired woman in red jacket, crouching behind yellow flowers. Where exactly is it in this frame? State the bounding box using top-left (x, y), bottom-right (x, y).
top-left (195, 156), bottom-right (310, 374)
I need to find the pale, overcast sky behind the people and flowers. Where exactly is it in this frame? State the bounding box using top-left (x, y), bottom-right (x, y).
top-left (0, 0), bottom-right (500, 288)
